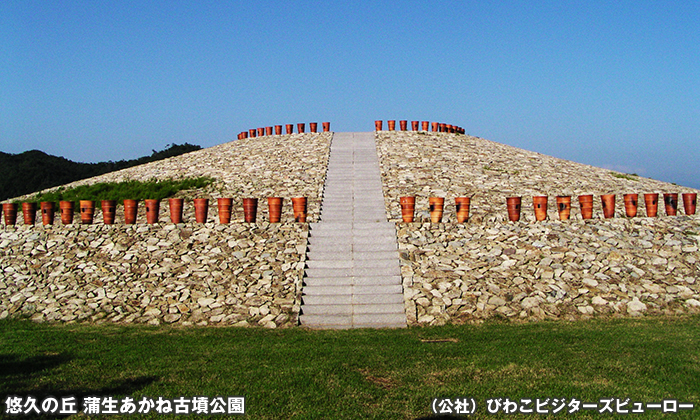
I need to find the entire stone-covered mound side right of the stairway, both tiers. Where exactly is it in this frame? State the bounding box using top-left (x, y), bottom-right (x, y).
top-left (377, 132), bottom-right (700, 325)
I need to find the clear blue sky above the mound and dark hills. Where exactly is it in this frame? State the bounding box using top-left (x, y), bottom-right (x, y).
top-left (0, 0), bottom-right (700, 188)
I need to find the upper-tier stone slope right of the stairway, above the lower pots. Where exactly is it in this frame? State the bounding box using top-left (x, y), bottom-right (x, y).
top-left (377, 131), bottom-right (696, 223)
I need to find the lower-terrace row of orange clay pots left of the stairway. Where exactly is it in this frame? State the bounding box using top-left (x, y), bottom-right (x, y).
top-left (2, 197), bottom-right (307, 225)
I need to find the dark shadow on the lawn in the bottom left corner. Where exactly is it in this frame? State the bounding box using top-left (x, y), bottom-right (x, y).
top-left (0, 354), bottom-right (159, 419)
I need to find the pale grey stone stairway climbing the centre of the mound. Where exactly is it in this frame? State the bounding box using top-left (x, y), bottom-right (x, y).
top-left (299, 133), bottom-right (406, 328)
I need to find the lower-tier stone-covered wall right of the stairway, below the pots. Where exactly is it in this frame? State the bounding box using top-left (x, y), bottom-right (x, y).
top-left (397, 216), bottom-right (700, 325)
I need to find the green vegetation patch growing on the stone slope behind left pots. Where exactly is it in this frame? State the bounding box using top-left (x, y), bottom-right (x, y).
top-left (21, 177), bottom-right (214, 203)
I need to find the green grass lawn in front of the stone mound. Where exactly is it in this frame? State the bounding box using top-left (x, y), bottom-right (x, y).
top-left (0, 316), bottom-right (700, 419)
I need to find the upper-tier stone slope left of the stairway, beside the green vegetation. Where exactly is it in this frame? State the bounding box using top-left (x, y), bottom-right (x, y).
top-left (15, 132), bottom-right (332, 223)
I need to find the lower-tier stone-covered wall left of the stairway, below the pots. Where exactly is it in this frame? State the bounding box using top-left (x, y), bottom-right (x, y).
top-left (0, 223), bottom-right (308, 328)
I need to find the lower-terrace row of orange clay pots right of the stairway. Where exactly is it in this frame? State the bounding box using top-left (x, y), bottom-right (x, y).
top-left (399, 193), bottom-right (697, 223)
